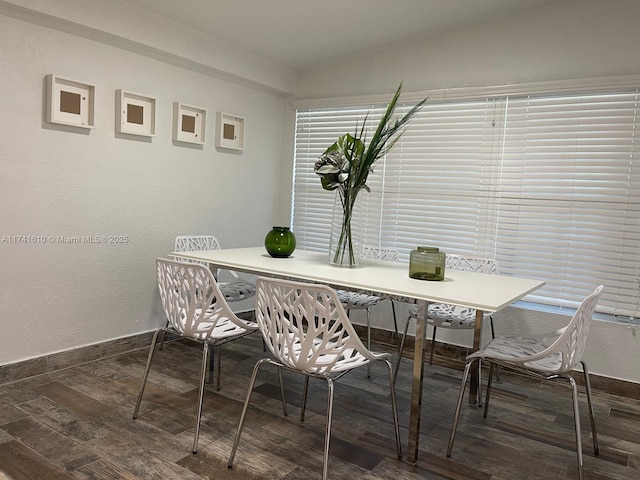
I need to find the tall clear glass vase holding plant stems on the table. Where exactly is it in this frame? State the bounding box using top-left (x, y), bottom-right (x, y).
top-left (329, 194), bottom-right (362, 268)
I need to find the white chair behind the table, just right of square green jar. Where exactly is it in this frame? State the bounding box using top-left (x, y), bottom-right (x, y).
top-left (395, 254), bottom-right (499, 376)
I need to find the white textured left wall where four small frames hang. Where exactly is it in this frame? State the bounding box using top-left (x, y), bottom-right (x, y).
top-left (0, 0), bottom-right (291, 364)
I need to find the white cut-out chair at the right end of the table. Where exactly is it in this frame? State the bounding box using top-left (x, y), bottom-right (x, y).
top-left (447, 285), bottom-right (604, 480)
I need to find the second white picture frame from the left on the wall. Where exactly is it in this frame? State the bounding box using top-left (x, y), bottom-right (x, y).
top-left (116, 89), bottom-right (156, 137)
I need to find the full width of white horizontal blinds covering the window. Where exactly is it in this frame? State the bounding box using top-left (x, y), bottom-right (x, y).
top-left (292, 89), bottom-right (640, 315)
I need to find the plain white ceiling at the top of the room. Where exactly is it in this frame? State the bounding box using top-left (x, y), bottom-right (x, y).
top-left (124, 0), bottom-right (550, 69)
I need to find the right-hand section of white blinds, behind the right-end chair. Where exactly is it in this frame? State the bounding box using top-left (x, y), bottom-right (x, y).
top-left (497, 90), bottom-right (640, 315)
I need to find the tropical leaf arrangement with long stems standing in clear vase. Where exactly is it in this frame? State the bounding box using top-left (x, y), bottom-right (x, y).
top-left (314, 82), bottom-right (427, 267)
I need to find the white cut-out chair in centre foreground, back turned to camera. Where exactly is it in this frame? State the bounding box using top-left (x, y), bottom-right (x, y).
top-left (228, 277), bottom-right (402, 480)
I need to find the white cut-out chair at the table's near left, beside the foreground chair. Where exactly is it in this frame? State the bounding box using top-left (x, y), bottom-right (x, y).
top-left (133, 258), bottom-right (258, 453)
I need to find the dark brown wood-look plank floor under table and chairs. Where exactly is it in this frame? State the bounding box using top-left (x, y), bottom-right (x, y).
top-left (0, 335), bottom-right (640, 480)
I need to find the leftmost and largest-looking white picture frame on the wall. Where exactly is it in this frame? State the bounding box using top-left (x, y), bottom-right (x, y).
top-left (45, 74), bottom-right (96, 129)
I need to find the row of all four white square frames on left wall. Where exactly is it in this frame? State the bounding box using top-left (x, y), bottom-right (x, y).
top-left (45, 74), bottom-right (244, 152)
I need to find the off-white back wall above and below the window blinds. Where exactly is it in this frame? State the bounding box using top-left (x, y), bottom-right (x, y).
top-left (286, 0), bottom-right (640, 382)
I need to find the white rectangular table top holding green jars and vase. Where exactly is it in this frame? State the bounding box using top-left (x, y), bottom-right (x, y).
top-left (171, 247), bottom-right (545, 312)
